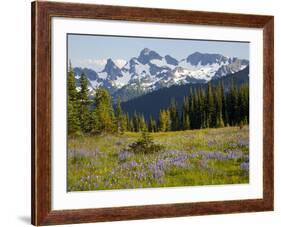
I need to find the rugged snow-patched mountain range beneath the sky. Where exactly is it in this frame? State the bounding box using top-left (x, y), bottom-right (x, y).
top-left (74, 48), bottom-right (249, 101)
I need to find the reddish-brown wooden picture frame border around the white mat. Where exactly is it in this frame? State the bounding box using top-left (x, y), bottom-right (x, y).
top-left (31, 1), bottom-right (274, 225)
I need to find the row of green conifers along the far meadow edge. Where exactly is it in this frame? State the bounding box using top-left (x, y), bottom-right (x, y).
top-left (67, 66), bottom-right (249, 135)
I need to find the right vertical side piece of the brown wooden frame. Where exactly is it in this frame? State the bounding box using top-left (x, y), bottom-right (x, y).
top-left (263, 18), bottom-right (274, 210)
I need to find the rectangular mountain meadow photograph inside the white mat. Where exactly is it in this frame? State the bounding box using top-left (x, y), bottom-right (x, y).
top-left (67, 34), bottom-right (250, 191)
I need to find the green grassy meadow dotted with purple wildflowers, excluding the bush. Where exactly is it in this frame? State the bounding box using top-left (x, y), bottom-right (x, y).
top-left (67, 127), bottom-right (249, 191)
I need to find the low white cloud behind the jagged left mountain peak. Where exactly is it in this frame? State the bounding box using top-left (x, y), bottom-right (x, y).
top-left (73, 58), bottom-right (127, 72)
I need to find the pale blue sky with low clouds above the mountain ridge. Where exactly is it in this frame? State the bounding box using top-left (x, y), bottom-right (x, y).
top-left (68, 34), bottom-right (249, 71)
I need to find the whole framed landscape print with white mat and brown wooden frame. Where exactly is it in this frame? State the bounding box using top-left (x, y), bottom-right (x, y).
top-left (32, 1), bottom-right (274, 225)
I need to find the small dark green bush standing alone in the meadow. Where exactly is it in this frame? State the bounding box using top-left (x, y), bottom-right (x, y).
top-left (128, 131), bottom-right (164, 154)
